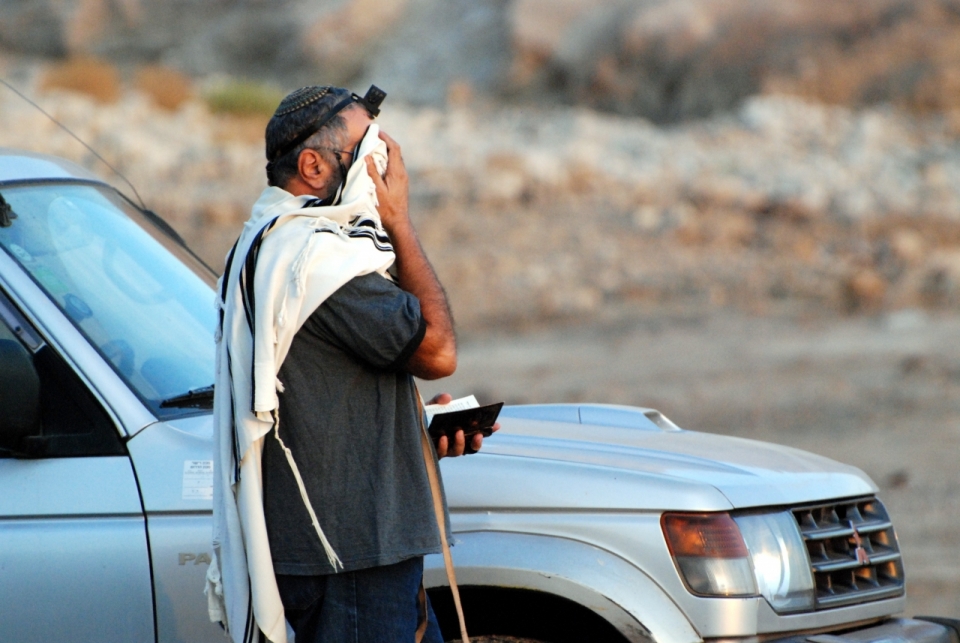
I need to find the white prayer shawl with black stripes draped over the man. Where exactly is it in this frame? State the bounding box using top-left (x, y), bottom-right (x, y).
top-left (205, 125), bottom-right (395, 643)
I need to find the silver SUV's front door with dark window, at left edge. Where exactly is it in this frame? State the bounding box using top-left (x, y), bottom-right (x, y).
top-left (0, 292), bottom-right (155, 643)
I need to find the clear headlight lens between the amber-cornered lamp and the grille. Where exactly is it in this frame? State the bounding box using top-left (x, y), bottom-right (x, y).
top-left (734, 511), bottom-right (815, 613)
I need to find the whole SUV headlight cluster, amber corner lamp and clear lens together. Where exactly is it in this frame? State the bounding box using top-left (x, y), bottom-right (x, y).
top-left (660, 512), bottom-right (814, 613)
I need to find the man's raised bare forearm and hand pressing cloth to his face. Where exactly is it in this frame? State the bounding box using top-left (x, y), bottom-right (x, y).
top-left (366, 132), bottom-right (457, 380)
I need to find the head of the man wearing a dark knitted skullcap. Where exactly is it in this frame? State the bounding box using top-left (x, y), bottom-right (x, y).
top-left (266, 86), bottom-right (373, 199)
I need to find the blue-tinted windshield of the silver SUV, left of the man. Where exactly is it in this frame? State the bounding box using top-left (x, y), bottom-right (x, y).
top-left (0, 183), bottom-right (216, 418)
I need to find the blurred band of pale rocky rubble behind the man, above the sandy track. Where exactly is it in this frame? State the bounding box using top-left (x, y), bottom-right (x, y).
top-left (0, 56), bottom-right (960, 331)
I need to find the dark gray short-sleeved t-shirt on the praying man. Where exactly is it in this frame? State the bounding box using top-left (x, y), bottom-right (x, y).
top-left (262, 273), bottom-right (440, 575)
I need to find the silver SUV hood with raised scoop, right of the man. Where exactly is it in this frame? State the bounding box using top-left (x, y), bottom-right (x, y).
top-left (441, 405), bottom-right (877, 511)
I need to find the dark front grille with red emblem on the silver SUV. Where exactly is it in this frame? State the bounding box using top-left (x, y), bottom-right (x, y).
top-left (793, 498), bottom-right (904, 610)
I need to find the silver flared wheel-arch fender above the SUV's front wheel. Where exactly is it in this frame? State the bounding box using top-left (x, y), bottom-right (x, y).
top-left (424, 531), bottom-right (702, 643)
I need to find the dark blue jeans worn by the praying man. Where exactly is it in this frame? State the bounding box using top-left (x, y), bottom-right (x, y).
top-left (277, 557), bottom-right (443, 643)
